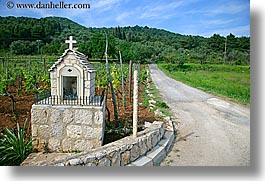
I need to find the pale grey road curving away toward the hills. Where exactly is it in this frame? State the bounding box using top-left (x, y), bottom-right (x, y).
top-left (150, 64), bottom-right (250, 166)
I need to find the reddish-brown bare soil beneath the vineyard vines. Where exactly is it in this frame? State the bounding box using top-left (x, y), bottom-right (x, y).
top-left (0, 80), bottom-right (157, 138)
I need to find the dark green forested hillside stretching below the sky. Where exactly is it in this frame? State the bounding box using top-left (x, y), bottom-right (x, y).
top-left (0, 17), bottom-right (250, 64)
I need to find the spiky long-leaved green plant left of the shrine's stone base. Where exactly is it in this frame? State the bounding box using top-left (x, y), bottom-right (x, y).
top-left (0, 120), bottom-right (32, 166)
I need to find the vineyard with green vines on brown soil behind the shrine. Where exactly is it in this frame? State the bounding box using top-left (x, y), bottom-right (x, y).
top-left (0, 56), bottom-right (157, 143)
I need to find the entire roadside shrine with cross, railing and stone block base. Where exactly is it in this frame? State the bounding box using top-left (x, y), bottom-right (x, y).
top-left (31, 36), bottom-right (106, 152)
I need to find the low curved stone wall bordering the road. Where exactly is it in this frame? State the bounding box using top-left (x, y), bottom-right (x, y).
top-left (21, 122), bottom-right (174, 166)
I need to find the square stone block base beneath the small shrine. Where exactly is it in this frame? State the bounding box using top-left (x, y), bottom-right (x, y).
top-left (31, 104), bottom-right (105, 152)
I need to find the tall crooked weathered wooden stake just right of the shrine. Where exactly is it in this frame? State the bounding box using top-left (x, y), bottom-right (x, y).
top-left (105, 35), bottom-right (118, 121)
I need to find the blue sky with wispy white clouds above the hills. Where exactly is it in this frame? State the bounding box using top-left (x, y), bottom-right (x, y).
top-left (0, 0), bottom-right (250, 37)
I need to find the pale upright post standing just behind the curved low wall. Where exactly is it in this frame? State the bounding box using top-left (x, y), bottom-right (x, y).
top-left (133, 69), bottom-right (138, 138)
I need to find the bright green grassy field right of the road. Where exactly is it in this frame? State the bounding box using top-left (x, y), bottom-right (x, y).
top-left (158, 63), bottom-right (250, 105)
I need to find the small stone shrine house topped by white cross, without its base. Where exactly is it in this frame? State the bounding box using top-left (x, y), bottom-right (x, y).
top-left (50, 36), bottom-right (96, 99)
